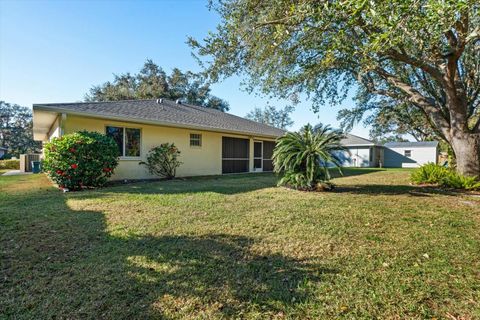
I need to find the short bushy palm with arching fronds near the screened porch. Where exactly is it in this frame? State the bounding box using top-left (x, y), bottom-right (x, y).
top-left (273, 124), bottom-right (346, 190)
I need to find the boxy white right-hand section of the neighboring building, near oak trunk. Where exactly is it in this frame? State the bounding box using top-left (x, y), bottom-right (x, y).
top-left (384, 141), bottom-right (438, 168)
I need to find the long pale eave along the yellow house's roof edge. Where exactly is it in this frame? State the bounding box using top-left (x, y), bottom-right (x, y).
top-left (32, 104), bottom-right (281, 139)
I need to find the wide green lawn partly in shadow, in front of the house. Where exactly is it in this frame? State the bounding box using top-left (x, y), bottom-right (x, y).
top-left (0, 169), bottom-right (480, 319)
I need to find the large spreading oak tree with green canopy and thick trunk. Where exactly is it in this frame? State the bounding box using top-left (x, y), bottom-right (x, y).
top-left (189, 0), bottom-right (480, 175)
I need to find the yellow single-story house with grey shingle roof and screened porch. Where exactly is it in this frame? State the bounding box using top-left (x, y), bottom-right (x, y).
top-left (33, 99), bottom-right (285, 179)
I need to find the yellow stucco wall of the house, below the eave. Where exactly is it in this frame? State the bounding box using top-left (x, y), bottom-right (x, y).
top-left (62, 115), bottom-right (273, 180)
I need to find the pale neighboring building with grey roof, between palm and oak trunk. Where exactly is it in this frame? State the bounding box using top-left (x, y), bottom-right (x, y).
top-left (341, 134), bottom-right (438, 168)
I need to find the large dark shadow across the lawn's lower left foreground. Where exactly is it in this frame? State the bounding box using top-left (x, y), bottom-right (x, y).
top-left (0, 186), bottom-right (337, 319)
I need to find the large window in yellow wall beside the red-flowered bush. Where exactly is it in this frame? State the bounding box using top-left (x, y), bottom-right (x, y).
top-left (105, 126), bottom-right (140, 157)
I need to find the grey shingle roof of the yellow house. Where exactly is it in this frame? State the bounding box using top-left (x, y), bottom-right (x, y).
top-left (33, 99), bottom-right (285, 137)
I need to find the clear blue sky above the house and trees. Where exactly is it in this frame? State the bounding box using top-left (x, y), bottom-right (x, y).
top-left (0, 0), bottom-right (368, 137)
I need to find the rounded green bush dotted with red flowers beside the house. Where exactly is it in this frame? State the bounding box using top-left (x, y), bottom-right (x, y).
top-left (42, 131), bottom-right (118, 190)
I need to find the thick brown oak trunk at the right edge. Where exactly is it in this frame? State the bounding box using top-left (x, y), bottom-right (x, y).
top-left (451, 133), bottom-right (480, 177)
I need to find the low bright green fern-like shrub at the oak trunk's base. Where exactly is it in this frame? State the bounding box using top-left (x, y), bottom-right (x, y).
top-left (410, 163), bottom-right (480, 190)
